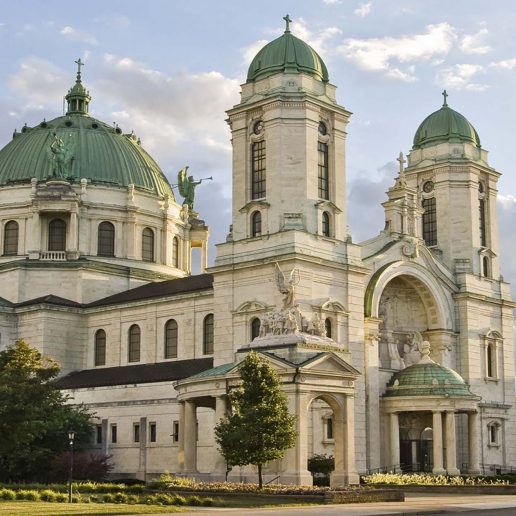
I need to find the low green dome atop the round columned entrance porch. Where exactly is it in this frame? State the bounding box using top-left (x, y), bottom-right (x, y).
top-left (384, 357), bottom-right (475, 398)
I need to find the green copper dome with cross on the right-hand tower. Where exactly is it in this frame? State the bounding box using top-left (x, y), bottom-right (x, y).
top-left (414, 91), bottom-right (480, 149)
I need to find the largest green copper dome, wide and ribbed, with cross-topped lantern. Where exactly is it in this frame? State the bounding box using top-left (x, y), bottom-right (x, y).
top-left (0, 63), bottom-right (174, 198)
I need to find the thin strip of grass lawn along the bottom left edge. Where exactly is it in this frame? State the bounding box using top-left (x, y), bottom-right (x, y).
top-left (0, 501), bottom-right (184, 516)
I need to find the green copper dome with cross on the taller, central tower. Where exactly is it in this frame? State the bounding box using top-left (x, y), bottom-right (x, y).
top-left (247, 14), bottom-right (329, 82)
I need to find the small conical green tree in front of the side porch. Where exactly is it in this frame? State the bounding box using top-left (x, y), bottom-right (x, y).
top-left (215, 351), bottom-right (297, 489)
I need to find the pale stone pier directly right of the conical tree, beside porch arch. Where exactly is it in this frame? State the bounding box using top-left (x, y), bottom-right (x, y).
top-left (280, 392), bottom-right (313, 485)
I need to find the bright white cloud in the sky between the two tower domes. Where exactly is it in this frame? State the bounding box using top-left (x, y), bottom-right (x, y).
top-left (337, 22), bottom-right (456, 81)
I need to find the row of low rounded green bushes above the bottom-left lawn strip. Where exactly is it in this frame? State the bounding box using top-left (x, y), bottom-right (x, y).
top-left (0, 488), bottom-right (215, 507)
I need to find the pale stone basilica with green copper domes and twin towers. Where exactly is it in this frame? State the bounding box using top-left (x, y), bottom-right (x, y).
top-left (0, 16), bottom-right (516, 487)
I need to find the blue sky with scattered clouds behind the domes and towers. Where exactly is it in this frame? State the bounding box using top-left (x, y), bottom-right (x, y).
top-left (0, 0), bottom-right (516, 294)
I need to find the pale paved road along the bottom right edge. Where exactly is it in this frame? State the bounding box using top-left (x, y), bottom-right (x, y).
top-left (171, 494), bottom-right (516, 516)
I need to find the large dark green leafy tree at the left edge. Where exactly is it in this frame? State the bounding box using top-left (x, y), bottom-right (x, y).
top-left (0, 340), bottom-right (92, 481)
